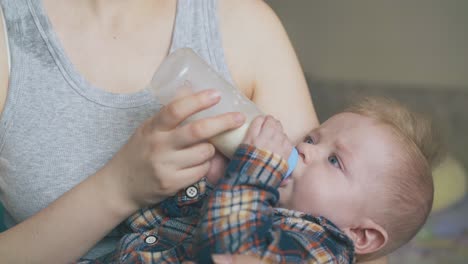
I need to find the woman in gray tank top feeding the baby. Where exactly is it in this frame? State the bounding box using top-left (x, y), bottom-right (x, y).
top-left (0, 0), bottom-right (318, 263)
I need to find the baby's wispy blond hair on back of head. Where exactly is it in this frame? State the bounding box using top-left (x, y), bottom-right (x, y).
top-left (346, 97), bottom-right (442, 259)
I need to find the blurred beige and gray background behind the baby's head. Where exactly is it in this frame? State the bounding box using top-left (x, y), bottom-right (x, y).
top-left (266, 0), bottom-right (468, 264)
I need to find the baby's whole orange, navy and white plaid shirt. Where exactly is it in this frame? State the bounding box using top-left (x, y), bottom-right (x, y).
top-left (82, 145), bottom-right (355, 263)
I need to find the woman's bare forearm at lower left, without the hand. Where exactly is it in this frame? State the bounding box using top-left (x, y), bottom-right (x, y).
top-left (0, 168), bottom-right (136, 263)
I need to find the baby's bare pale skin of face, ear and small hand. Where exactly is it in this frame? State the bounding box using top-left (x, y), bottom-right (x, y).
top-left (242, 115), bottom-right (394, 262)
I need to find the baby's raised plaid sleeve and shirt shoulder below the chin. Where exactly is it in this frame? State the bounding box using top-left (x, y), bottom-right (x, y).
top-left (194, 145), bottom-right (354, 263)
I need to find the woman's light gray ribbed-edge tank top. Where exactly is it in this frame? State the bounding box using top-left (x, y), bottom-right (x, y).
top-left (0, 0), bottom-right (232, 257)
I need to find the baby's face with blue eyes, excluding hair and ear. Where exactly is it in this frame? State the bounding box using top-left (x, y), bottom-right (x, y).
top-left (279, 113), bottom-right (397, 228)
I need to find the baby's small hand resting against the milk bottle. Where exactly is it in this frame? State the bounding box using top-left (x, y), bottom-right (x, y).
top-left (242, 116), bottom-right (293, 159)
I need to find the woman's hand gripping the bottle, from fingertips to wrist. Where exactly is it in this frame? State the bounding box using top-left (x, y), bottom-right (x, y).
top-left (105, 90), bottom-right (245, 209)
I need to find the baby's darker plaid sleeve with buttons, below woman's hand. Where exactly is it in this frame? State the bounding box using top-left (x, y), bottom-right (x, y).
top-left (78, 179), bottom-right (213, 264)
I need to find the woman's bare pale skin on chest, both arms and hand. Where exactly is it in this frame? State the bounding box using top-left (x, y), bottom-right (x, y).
top-left (0, 0), bottom-right (386, 263)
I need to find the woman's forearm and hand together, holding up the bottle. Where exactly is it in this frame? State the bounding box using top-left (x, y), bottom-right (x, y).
top-left (0, 91), bottom-right (244, 263)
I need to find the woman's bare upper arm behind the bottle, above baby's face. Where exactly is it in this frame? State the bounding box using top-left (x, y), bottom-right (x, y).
top-left (219, 0), bottom-right (318, 143)
